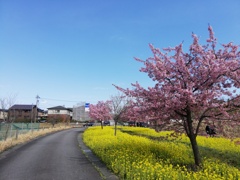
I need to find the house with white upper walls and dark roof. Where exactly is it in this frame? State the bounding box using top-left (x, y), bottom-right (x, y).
top-left (48, 106), bottom-right (72, 123)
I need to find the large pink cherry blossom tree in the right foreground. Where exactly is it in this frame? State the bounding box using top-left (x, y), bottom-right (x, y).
top-left (116, 26), bottom-right (240, 166)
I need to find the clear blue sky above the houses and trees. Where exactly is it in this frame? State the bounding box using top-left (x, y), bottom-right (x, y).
top-left (0, 0), bottom-right (240, 109)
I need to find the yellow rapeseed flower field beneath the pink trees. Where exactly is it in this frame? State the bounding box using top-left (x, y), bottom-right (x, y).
top-left (83, 126), bottom-right (240, 180)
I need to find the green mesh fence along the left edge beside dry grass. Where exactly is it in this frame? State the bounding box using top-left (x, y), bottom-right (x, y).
top-left (0, 123), bottom-right (40, 141)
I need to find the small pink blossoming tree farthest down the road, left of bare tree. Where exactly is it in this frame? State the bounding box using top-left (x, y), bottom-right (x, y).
top-left (89, 101), bottom-right (112, 128)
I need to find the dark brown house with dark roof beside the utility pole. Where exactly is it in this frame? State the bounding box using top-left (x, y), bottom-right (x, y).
top-left (8, 104), bottom-right (42, 122)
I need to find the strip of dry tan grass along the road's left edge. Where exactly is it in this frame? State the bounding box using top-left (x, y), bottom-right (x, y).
top-left (0, 126), bottom-right (70, 153)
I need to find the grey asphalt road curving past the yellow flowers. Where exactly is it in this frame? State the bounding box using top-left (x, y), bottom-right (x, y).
top-left (0, 128), bottom-right (106, 180)
